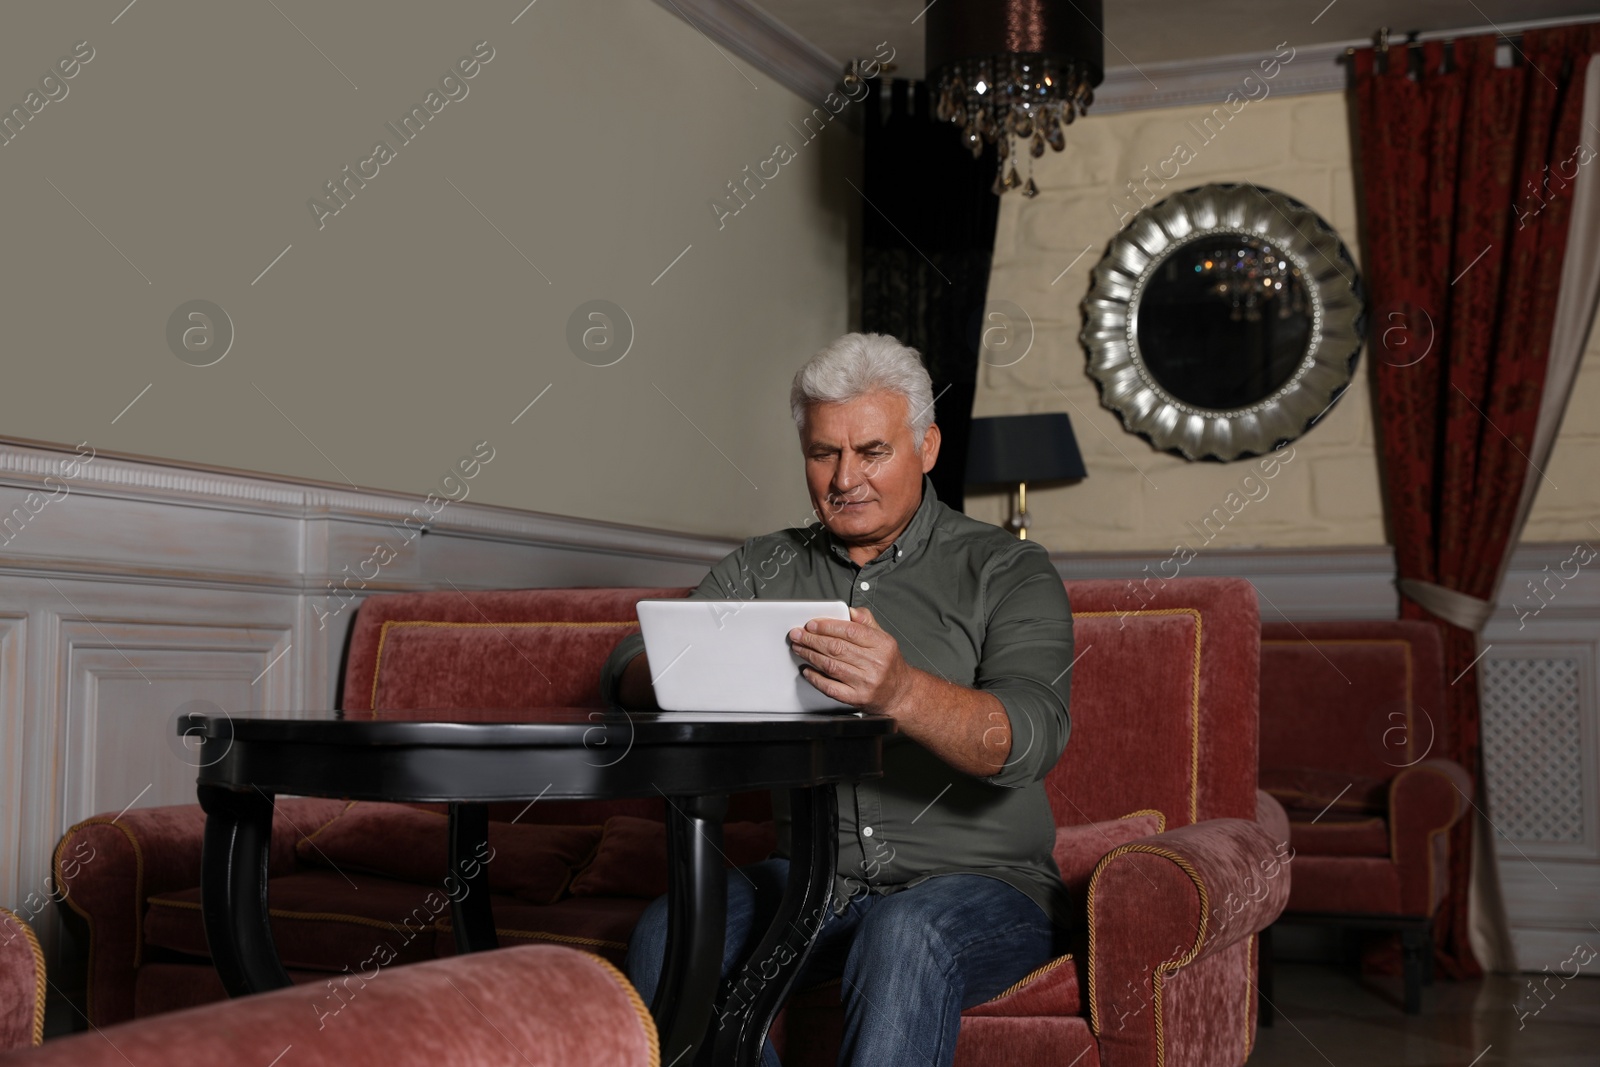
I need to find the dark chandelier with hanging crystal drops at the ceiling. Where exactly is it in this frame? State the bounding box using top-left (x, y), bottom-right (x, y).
top-left (926, 0), bottom-right (1104, 197)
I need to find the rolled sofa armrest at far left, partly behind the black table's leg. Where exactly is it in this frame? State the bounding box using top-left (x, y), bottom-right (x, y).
top-left (54, 797), bottom-right (346, 1025)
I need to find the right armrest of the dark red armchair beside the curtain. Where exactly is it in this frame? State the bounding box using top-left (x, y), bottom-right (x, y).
top-left (1389, 760), bottom-right (1472, 915)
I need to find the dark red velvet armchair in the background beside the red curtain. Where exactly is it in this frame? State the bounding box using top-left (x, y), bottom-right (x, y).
top-left (1261, 621), bottom-right (1472, 1014)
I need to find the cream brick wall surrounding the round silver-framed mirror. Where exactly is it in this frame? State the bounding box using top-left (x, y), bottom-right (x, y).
top-left (968, 93), bottom-right (1600, 557)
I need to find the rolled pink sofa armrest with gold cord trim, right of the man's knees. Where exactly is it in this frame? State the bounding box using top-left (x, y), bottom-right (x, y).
top-left (1088, 819), bottom-right (1293, 1064)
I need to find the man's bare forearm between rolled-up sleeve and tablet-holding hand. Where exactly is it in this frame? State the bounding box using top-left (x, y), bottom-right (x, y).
top-left (883, 667), bottom-right (1011, 777)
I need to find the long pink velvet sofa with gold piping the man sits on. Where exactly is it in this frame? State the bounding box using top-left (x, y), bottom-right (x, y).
top-left (58, 579), bottom-right (1290, 1067)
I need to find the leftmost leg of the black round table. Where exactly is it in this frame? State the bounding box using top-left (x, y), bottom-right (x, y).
top-left (198, 785), bottom-right (290, 997)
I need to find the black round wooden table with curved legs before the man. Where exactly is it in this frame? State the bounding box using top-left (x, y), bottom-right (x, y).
top-left (178, 709), bottom-right (894, 1067)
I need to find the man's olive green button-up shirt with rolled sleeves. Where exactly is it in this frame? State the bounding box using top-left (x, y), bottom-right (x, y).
top-left (600, 477), bottom-right (1072, 928)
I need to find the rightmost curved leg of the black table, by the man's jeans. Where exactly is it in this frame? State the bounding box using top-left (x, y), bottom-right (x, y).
top-left (712, 785), bottom-right (838, 1067)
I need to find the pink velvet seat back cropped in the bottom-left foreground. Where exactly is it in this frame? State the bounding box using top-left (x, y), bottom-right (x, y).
top-left (0, 945), bottom-right (661, 1067)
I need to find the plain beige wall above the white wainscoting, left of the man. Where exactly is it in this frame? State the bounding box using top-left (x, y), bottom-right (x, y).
top-left (0, 0), bottom-right (859, 534)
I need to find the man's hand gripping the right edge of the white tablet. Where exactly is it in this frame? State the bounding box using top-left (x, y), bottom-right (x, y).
top-left (789, 608), bottom-right (915, 715)
